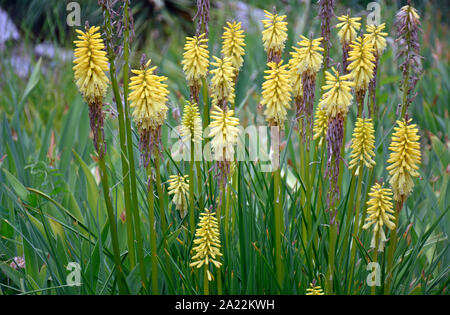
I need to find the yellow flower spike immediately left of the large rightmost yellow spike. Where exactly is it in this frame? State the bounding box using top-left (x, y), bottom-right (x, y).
top-left (350, 117), bottom-right (375, 176)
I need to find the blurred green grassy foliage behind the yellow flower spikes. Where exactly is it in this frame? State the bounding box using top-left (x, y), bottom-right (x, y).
top-left (0, 0), bottom-right (450, 294)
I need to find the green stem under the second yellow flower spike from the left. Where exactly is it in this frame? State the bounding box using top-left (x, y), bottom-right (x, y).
top-left (147, 165), bottom-right (159, 294)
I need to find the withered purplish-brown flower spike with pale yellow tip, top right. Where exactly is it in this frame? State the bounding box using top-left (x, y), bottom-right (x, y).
top-left (395, 1), bottom-right (422, 118)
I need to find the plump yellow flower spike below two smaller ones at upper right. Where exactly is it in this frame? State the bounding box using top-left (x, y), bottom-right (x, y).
top-left (347, 37), bottom-right (375, 91)
